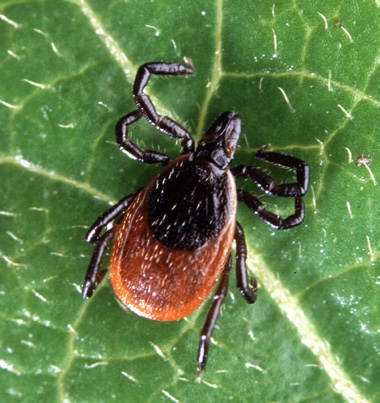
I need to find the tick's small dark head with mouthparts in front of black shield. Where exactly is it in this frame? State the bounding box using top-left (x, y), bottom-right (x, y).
top-left (195, 112), bottom-right (241, 169)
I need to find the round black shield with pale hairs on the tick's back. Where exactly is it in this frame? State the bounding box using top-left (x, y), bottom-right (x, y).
top-left (149, 159), bottom-right (231, 250)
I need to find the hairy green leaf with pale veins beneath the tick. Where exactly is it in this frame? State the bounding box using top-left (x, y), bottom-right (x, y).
top-left (0, 0), bottom-right (380, 402)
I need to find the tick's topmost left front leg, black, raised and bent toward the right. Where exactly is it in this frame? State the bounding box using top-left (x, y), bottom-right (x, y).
top-left (132, 59), bottom-right (194, 154)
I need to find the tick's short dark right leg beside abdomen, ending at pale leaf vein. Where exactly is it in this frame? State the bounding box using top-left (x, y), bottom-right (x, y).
top-left (235, 222), bottom-right (257, 304)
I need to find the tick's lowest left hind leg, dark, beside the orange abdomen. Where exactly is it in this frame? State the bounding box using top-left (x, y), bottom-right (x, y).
top-left (82, 226), bottom-right (117, 298)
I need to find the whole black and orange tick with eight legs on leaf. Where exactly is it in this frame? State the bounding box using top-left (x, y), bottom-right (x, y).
top-left (83, 59), bottom-right (310, 374)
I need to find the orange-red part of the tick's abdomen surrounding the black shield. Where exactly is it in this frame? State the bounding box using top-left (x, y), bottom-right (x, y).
top-left (110, 156), bottom-right (236, 321)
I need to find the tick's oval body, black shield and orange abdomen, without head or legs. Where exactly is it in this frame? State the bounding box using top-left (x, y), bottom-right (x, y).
top-left (110, 154), bottom-right (237, 321)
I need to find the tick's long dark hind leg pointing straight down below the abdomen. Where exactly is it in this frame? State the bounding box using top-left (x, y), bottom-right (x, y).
top-left (198, 255), bottom-right (232, 379)
